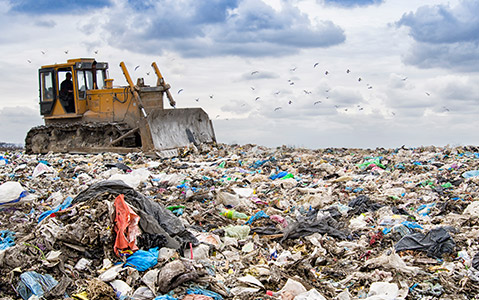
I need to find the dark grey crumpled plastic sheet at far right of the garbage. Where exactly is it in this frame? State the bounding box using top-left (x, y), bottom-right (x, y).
top-left (394, 227), bottom-right (456, 258)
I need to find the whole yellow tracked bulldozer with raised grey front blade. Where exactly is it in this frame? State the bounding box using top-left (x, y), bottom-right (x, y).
top-left (25, 58), bottom-right (216, 156)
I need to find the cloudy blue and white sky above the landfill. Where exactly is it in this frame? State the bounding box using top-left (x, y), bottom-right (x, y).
top-left (0, 0), bottom-right (479, 148)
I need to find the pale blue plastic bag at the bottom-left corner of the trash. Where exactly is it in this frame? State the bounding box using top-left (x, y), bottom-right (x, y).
top-left (17, 271), bottom-right (58, 300)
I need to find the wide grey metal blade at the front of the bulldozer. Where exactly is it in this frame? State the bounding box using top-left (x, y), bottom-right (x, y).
top-left (147, 108), bottom-right (216, 150)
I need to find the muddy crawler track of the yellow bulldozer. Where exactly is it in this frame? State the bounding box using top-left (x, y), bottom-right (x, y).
top-left (25, 123), bottom-right (141, 153)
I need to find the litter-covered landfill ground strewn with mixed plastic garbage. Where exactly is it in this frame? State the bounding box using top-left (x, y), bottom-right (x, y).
top-left (0, 144), bottom-right (479, 300)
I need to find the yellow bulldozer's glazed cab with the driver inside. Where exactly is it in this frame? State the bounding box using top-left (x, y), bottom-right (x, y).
top-left (39, 59), bottom-right (108, 117)
